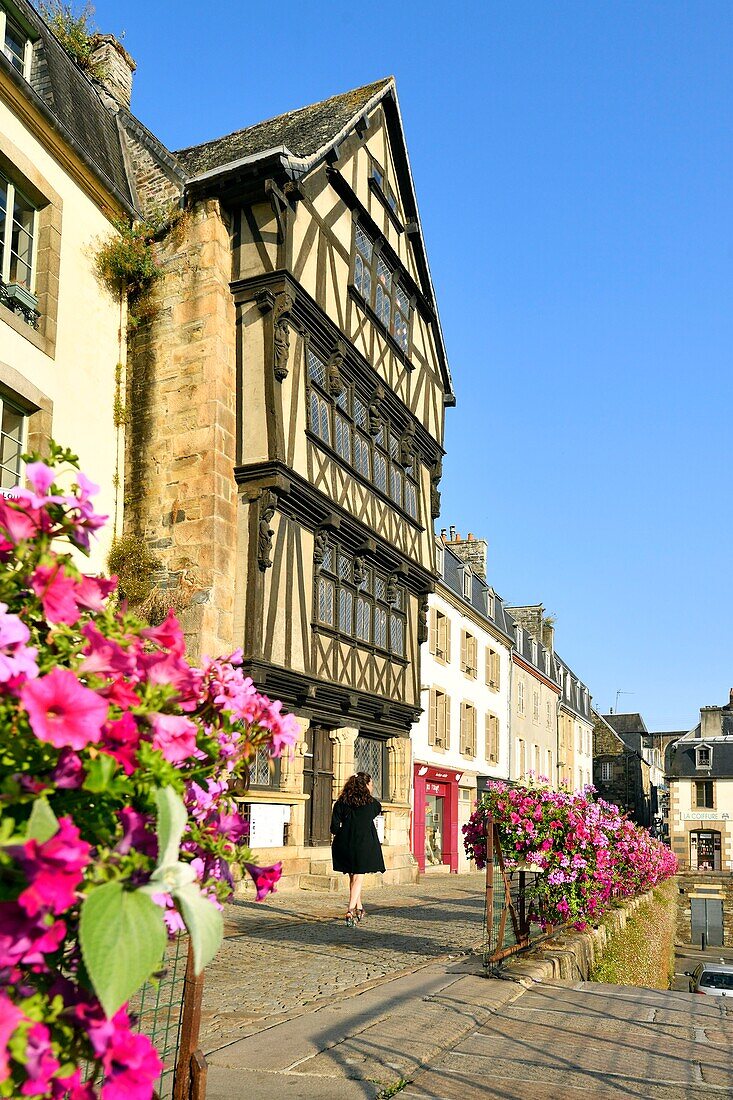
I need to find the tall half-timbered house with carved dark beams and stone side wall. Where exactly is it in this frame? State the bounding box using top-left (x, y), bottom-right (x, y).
top-left (110, 79), bottom-right (453, 884)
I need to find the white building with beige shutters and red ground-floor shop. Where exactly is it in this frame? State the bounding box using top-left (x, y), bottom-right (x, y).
top-left (412, 530), bottom-right (512, 871)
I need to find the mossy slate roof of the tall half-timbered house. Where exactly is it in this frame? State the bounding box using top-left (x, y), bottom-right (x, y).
top-left (175, 77), bottom-right (392, 176)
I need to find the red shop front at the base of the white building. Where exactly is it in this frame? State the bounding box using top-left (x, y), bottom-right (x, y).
top-left (413, 763), bottom-right (463, 873)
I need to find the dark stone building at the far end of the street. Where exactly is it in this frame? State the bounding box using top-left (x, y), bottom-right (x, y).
top-left (592, 711), bottom-right (654, 828)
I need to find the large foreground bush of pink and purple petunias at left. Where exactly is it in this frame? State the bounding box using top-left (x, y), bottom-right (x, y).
top-left (0, 446), bottom-right (297, 1100)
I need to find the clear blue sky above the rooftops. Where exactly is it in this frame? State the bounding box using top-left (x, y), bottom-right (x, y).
top-left (96, 0), bottom-right (733, 729)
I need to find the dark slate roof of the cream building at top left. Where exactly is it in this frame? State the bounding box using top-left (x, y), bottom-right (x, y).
top-left (0, 0), bottom-right (132, 209)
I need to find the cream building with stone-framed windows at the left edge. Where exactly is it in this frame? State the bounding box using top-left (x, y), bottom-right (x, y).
top-left (0, 0), bottom-right (134, 571)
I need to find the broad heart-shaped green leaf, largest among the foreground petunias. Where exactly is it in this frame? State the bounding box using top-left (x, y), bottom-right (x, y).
top-left (79, 882), bottom-right (167, 1016)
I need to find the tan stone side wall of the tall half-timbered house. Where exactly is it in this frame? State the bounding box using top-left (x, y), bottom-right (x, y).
top-left (124, 201), bottom-right (237, 660)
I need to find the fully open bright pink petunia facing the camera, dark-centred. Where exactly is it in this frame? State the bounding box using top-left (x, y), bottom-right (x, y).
top-left (21, 668), bottom-right (108, 749)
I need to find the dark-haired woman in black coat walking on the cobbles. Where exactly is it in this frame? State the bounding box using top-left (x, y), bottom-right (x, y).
top-left (331, 771), bottom-right (384, 927)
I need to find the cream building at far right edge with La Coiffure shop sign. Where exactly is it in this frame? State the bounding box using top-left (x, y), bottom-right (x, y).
top-left (668, 691), bottom-right (733, 873)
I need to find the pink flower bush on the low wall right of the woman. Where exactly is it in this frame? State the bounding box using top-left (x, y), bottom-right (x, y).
top-left (463, 782), bottom-right (677, 927)
